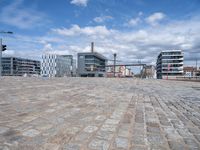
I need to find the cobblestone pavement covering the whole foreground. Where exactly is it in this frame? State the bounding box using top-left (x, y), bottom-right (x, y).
top-left (0, 77), bottom-right (200, 150)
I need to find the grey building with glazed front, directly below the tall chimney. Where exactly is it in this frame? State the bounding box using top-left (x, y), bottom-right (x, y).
top-left (77, 52), bottom-right (107, 77)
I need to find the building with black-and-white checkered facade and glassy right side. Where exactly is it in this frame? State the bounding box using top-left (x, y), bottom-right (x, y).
top-left (41, 53), bottom-right (76, 77)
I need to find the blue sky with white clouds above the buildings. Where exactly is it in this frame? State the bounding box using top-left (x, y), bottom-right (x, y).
top-left (0, 0), bottom-right (200, 65)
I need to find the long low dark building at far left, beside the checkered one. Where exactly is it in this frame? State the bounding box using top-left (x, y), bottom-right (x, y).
top-left (2, 57), bottom-right (40, 76)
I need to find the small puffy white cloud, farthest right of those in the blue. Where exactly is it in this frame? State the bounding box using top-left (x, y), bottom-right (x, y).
top-left (146, 12), bottom-right (165, 26)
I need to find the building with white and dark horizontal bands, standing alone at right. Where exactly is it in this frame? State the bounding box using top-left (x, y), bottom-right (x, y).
top-left (156, 50), bottom-right (184, 79)
